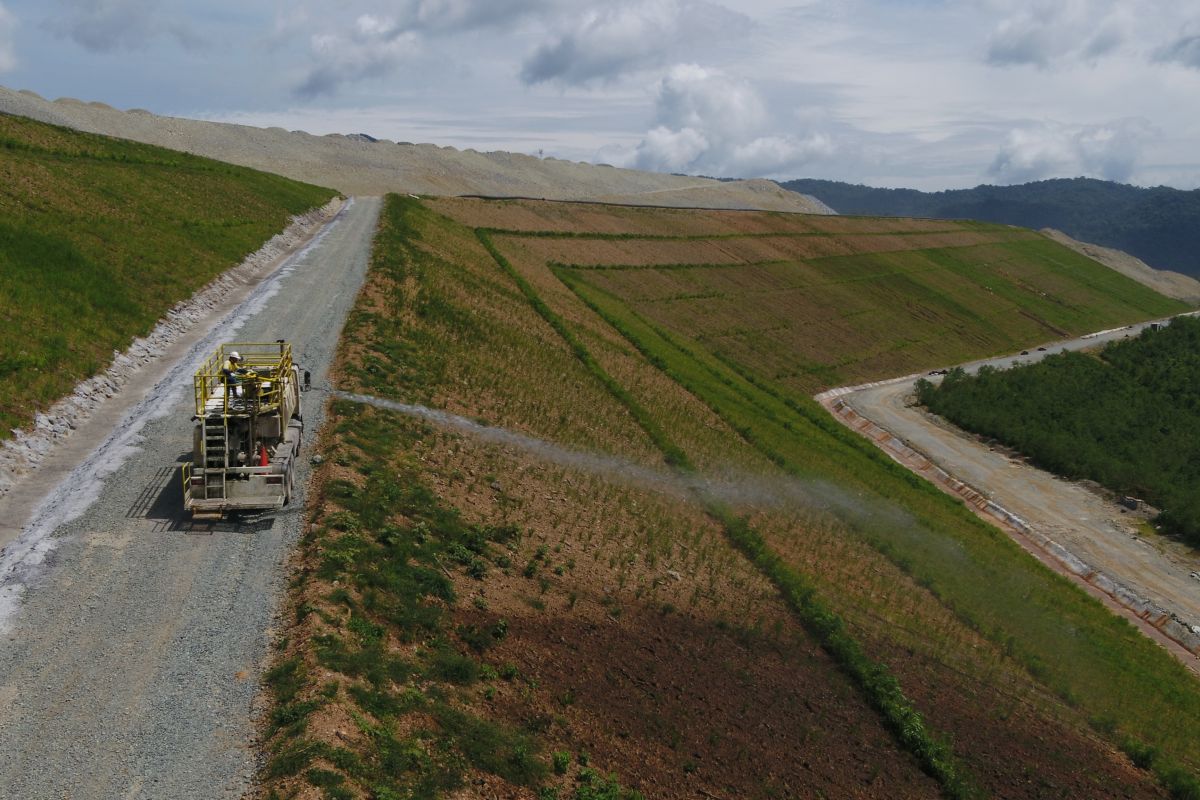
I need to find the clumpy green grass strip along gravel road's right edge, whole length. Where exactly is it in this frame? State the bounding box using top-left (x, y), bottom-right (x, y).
top-left (264, 196), bottom-right (662, 800)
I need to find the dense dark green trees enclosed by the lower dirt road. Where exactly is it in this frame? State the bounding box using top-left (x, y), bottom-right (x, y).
top-left (917, 318), bottom-right (1200, 546)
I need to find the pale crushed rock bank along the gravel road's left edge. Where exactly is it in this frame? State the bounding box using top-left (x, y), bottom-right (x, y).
top-left (0, 198), bottom-right (344, 497)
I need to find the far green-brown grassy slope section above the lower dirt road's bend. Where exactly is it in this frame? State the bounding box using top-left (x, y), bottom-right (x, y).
top-left (556, 233), bottom-right (1187, 393)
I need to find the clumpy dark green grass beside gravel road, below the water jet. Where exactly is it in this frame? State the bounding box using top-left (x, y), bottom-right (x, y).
top-left (268, 402), bottom-right (550, 798)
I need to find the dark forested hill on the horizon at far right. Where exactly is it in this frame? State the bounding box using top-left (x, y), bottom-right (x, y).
top-left (782, 178), bottom-right (1200, 277)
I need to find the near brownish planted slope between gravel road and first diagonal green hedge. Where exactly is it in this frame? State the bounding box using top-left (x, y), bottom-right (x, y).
top-left (266, 198), bottom-right (934, 799)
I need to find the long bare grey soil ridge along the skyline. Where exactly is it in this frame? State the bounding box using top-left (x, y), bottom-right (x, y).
top-left (0, 88), bottom-right (827, 213)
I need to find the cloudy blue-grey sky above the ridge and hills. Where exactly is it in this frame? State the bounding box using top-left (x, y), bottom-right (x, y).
top-left (0, 0), bottom-right (1200, 190)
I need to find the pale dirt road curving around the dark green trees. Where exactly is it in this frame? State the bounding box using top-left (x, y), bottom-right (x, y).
top-left (818, 316), bottom-right (1200, 666)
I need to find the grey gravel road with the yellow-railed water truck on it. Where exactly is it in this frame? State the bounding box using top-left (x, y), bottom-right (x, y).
top-left (0, 198), bottom-right (379, 800)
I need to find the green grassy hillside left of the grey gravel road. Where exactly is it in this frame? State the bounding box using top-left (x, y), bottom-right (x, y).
top-left (0, 115), bottom-right (334, 439)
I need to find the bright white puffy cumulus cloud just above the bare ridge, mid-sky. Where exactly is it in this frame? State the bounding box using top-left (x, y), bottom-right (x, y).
top-left (625, 65), bottom-right (835, 178)
